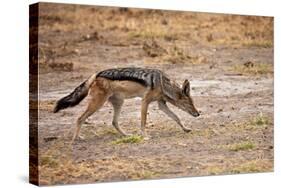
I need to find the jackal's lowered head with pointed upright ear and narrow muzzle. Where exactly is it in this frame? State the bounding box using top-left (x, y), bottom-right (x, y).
top-left (175, 80), bottom-right (200, 117)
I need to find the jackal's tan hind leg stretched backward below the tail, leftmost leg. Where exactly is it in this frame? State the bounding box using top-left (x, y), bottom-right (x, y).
top-left (71, 92), bottom-right (107, 143)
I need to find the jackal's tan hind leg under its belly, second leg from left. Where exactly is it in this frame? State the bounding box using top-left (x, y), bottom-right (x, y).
top-left (108, 97), bottom-right (129, 136)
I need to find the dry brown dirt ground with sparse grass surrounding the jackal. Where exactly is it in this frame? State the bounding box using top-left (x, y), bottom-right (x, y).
top-left (34, 3), bottom-right (274, 185)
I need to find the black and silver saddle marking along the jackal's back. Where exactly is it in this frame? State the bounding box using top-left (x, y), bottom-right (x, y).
top-left (96, 67), bottom-right (162, 88)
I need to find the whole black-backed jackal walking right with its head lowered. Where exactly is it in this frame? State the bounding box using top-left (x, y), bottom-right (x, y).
top-left (54, 68), bottom-right (199, 141)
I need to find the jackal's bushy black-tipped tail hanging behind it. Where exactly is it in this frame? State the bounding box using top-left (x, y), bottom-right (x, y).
top-left (53, 75), bottom-right (95, 113)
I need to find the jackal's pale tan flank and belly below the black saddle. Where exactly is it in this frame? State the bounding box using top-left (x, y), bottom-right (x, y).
top-left (110, 80), bottom-right (150, 99)
